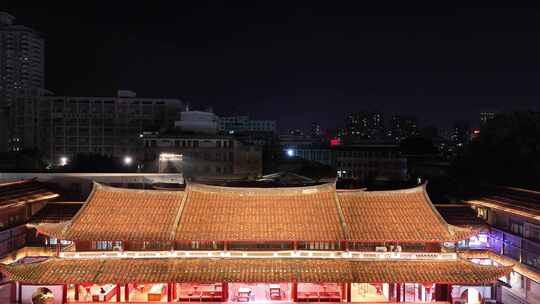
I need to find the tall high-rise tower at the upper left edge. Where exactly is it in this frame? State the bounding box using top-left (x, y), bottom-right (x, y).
top-left (0, 12), bottom-right (45, 107)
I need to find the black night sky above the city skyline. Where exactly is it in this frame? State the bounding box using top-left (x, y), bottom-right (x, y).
top-left (4, 1), bottom-right (540, 131)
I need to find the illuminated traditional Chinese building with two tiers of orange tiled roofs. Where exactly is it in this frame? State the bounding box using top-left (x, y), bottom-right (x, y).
top-left (1, 184), bottom-right (511, 303)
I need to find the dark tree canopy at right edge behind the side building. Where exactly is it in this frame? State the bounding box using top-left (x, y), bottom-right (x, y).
top-left (454, 112), bottom-right (540, 189)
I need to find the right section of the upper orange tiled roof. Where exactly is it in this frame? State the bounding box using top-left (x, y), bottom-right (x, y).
top-left (338, 185), bottom-right (471, 242)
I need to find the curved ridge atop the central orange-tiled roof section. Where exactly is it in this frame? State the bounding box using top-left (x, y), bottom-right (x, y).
top-left (186, 183), bottom-right (336, 196)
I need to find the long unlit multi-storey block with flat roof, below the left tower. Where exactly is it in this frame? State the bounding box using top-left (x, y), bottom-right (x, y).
top-left (12, 91), bottom-right (182, 164)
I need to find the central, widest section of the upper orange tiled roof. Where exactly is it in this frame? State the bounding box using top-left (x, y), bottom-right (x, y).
top-left (176, 184), bottom-right (344, 241)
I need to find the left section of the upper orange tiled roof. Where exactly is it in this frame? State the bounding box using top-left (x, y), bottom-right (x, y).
top-left (64, 184), bottom-right (184, 241)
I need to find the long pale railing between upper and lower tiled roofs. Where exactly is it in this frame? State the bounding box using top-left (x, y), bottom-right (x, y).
top-left (60, 250), bottom-right (457, 260)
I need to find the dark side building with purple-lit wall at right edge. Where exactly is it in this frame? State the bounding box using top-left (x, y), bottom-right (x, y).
top-left (467, 187), bottom-right (540, 304)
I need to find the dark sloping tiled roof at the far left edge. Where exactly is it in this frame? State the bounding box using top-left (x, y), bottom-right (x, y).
top-left (0, 179), bottom-right (58, 208)
